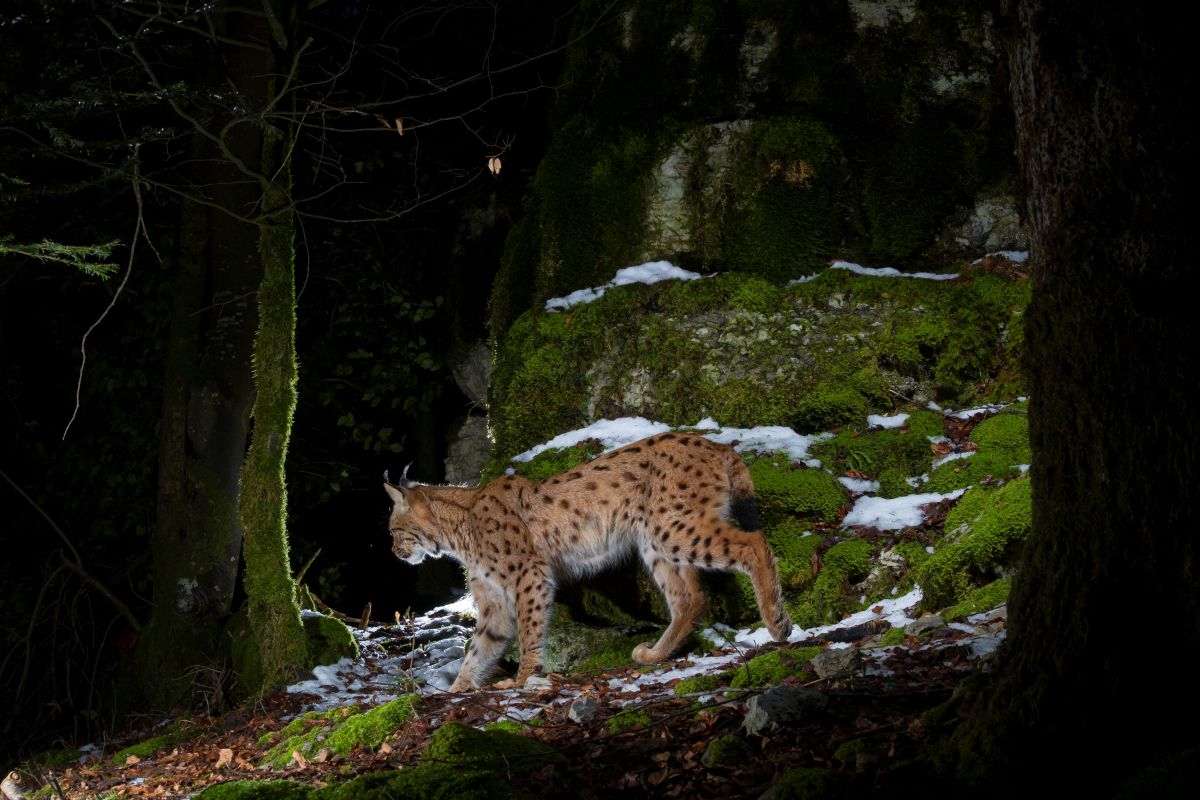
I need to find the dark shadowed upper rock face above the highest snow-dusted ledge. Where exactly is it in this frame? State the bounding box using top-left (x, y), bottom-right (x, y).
top-left (491, 0), bottom-right (1025, 336)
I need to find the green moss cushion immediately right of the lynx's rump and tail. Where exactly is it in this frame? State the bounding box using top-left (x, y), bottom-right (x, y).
top-left (750, 453), bottom-right (846, 525)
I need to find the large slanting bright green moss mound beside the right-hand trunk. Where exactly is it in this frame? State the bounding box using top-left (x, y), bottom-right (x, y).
top-left (916, 477), bottom-right (1032, 610)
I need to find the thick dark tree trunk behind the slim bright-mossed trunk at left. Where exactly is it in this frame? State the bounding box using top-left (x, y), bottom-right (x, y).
top-left (131, 6), bottom-right (270, 708)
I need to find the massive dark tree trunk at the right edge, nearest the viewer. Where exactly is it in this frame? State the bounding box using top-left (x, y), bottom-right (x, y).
top-left (955, 0), bottom-right (1200, 796)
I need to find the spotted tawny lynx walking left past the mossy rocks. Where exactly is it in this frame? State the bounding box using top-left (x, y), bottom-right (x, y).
top-left (384, 433), bottom-right (792, 692)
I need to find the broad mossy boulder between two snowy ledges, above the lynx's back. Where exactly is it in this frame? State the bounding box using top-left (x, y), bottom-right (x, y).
top-left (487, 270), bottom-right (1027, 465)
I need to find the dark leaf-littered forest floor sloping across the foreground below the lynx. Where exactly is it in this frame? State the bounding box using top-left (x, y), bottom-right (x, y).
top-left (26, 607), bottom-right (1006, 800)
